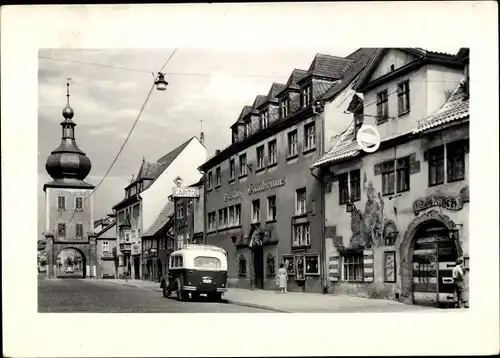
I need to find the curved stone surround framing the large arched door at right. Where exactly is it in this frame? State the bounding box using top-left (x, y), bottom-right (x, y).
top-left (399, 210), bottom-right (462, 304)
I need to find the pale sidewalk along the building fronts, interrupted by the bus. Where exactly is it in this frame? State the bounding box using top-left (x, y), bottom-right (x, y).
top-left (97, 279), bottom-right (455, 313)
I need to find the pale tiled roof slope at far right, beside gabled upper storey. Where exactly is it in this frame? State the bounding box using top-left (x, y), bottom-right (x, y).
top-left (413, 81), bottom-right (469, 133)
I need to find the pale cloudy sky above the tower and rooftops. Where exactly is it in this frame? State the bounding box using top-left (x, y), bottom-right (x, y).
top-left (38, 47), bottom-right (366, 238)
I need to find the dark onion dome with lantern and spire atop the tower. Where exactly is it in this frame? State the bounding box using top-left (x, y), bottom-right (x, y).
top-left (45, 83), bottom-right (92, 180)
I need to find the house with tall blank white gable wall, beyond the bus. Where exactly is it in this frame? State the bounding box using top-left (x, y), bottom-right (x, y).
top-left (113, 137), bottom-right (206, 279)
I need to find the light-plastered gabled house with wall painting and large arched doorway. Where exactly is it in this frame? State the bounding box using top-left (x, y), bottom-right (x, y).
top-left (313, 48), bottom-right (469, 304)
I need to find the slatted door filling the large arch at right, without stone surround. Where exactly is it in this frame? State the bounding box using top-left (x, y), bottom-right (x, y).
top-left (413, 222), bottom-right (458, 307)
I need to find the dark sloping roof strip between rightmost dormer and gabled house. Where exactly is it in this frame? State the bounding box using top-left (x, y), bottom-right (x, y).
top-left (321, 48), bottom-right (377, 101)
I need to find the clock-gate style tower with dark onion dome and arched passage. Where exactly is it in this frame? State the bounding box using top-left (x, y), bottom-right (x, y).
top-left (43, 81), bottom-right (96, 277)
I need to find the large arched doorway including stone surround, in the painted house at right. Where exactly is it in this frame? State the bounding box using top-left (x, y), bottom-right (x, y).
top-left (400, 210), bottom-right (462, 307)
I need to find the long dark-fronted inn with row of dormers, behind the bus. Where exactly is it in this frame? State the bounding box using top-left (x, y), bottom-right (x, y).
top-left (200, 49), bottom-right (374, 292)
